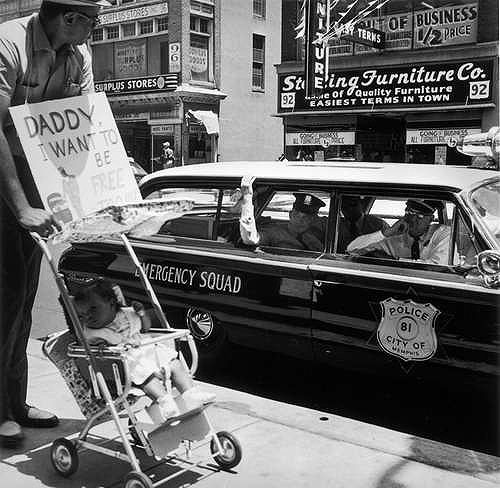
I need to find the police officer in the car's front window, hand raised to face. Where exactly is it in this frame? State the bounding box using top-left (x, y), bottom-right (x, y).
top-left (347, 199), bottom-right (450, 265)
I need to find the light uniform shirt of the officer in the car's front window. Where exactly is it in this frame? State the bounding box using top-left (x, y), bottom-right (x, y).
top-left (347, 224), bottom-right (450, 265)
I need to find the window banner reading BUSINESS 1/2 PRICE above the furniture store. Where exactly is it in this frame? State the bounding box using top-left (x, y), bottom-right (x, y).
top-left (413, 3), bottom-right (477, 49)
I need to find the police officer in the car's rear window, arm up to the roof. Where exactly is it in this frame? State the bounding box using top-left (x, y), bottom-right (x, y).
top-left (240, 178), bottom-right (326, 251)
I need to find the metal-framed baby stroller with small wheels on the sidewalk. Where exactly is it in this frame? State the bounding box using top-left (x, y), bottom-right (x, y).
top-left (32, 221), bottom-right (242, 488)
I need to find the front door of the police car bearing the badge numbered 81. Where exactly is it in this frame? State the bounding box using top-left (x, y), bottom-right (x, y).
top-left (310, 192), bottom-right (500, 379)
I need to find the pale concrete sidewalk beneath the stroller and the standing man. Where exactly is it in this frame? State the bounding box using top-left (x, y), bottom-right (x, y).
top-left (0, 340), bottom-right (500, 488)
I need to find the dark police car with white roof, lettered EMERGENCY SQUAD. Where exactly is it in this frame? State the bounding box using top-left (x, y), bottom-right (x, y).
top-left (59, 139), bottom-right (500, 381)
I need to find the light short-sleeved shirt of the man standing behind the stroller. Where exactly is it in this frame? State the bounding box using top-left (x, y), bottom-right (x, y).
top-left (0, 14), bottom-right (94, 155)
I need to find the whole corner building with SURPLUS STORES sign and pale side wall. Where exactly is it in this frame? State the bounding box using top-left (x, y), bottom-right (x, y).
top-left (0, 0), bottom-right (283, 171)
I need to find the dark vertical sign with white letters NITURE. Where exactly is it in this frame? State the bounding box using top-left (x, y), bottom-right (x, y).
top-left (305, 0), bottom-right (328, 97)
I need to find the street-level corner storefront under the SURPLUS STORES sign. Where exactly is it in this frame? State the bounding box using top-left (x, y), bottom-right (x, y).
top-left (96, 73), bottom-right (225, 172)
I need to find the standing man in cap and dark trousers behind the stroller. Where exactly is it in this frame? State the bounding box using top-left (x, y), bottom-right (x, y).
top-left (0, 0), bottom-right (111, 447)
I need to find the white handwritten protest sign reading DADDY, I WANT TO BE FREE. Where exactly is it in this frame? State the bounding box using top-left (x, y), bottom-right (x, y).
top-left (9, 93), bottom-right (142, 223)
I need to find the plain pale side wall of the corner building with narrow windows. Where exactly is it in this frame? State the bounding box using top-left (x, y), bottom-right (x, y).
top-left (219, 0), bottom-right (283, 161)
